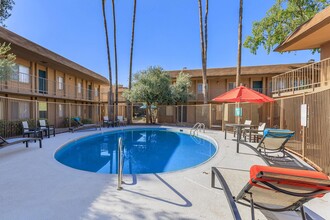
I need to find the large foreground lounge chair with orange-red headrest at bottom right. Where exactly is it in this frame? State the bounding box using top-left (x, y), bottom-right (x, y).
top-left (212, 165), bottom-right (330, 219)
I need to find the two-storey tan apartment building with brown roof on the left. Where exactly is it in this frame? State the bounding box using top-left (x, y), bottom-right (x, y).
top-left (0, 27), bottom-right (109, 126)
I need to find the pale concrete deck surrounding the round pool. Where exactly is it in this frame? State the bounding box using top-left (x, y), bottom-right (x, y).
top-left (0, 126), bottom-right (330, 220)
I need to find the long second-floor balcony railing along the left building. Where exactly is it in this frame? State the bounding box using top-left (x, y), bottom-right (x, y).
top-left (0, 73), bottom-right (107, 101)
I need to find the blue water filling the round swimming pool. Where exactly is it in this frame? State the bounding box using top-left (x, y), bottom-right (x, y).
top-left (55, 128), bottom-right (216, 174)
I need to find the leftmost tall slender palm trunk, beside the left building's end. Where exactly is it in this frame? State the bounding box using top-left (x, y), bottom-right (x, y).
top-left (102, 0), bottom-right (113, 122)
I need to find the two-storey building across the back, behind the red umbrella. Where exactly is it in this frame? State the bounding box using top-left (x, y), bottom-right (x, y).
top-left (169, 63), bottom-right (306, 104)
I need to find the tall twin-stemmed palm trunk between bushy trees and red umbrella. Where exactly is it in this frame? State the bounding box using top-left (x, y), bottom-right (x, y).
top-left (198, 0), bottom-right (209, 104)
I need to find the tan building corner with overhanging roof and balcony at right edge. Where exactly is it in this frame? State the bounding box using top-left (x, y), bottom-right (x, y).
top-left (272, 6), bottom-right (330, 97)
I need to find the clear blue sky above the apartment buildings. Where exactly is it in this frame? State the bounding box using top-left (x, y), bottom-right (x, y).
top-left (5, 0), bottom-right (319, 86)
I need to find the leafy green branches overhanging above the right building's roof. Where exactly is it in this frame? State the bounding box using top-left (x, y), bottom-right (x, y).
top-left (244, 0), bottom-right (330, 54)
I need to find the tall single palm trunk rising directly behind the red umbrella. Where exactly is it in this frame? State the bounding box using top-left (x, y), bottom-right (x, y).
top-left (236, 0), bottom-right (243, 124)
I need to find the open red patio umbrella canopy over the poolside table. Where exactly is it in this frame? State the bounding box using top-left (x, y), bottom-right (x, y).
top-left (212, 86), bottom-right (275, 103)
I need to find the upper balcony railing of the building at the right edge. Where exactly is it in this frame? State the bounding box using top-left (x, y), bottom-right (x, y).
top-left (272, 58), bottom-right (330, 95)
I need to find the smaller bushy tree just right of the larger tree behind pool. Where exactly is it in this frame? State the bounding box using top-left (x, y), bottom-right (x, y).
top-left (171, 72), bottom-right (193, 104)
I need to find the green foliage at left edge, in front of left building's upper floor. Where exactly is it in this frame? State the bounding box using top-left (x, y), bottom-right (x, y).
top-left (0, 43), bottom-right (17, 81)
